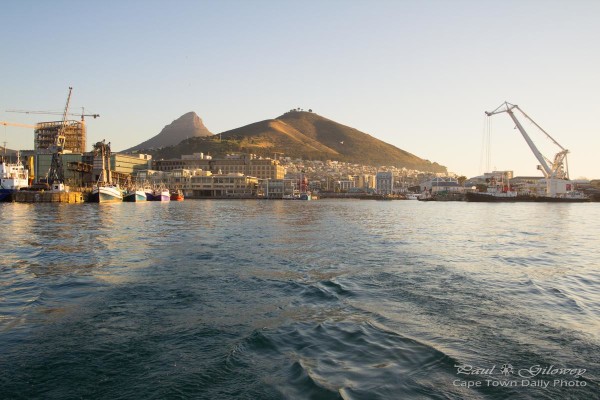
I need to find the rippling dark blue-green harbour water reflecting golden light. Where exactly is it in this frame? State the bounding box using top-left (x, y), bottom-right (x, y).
top-left (0, 200), bottom-right (600, 399)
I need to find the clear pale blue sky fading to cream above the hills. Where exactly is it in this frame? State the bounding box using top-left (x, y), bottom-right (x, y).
top-left (0, 0), bottom-right (600, 178)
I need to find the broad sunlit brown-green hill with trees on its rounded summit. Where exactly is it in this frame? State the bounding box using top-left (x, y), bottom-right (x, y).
top-left (142, 111), bottom-right (446, 172)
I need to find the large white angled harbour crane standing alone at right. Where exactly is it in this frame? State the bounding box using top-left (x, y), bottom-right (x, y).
top-left (485, 101), bottom-right (569, 197)
